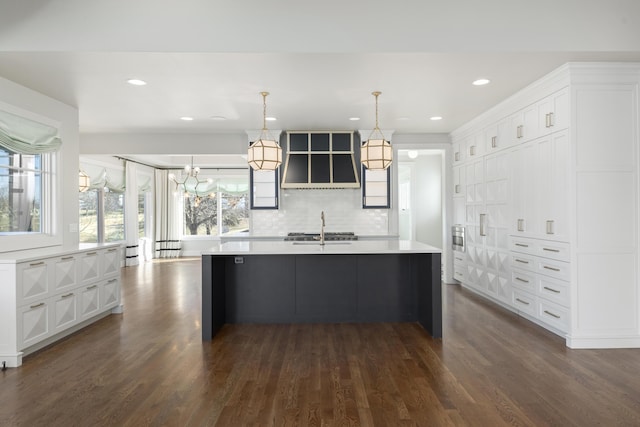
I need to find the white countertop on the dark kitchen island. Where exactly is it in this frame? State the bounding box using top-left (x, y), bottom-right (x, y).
top-left (202, 240), bottom-right (442, 255)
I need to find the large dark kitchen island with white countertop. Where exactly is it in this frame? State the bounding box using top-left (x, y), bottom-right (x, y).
top-left (202, 240), bottom-right (442, 340)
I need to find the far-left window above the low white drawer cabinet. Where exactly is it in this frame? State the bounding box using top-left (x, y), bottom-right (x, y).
top-left (0, 148), bottom-right (47, 234)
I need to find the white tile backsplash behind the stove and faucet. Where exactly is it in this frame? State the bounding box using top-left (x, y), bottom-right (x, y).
top-left (251, 189), bottom-right (389, 236)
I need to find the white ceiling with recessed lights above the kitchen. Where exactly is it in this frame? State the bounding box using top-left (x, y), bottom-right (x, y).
top-left (0, 0), bottom-right (640, 166)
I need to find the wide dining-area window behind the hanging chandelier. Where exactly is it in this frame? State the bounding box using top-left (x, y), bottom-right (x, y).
top-left (182, 171), bottom-right (250, 236)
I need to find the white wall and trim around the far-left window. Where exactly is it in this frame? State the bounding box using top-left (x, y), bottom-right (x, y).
top-left (0, 77), bottom-right (79, 252)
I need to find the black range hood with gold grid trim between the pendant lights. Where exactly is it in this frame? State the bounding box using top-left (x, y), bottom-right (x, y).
top-left (281, 131), bottom-right (360, 188)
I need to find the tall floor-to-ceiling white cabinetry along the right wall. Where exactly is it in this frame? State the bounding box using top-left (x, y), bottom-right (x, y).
top-left (451, 63), bottom-right (640, 348)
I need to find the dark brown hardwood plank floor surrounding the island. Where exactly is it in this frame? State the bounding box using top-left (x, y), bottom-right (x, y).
top-left (0, 259), bottom-right (640, 427)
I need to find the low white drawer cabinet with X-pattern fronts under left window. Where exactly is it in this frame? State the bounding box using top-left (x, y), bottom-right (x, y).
top-left (0, 245), bottom-right (121, 367)
